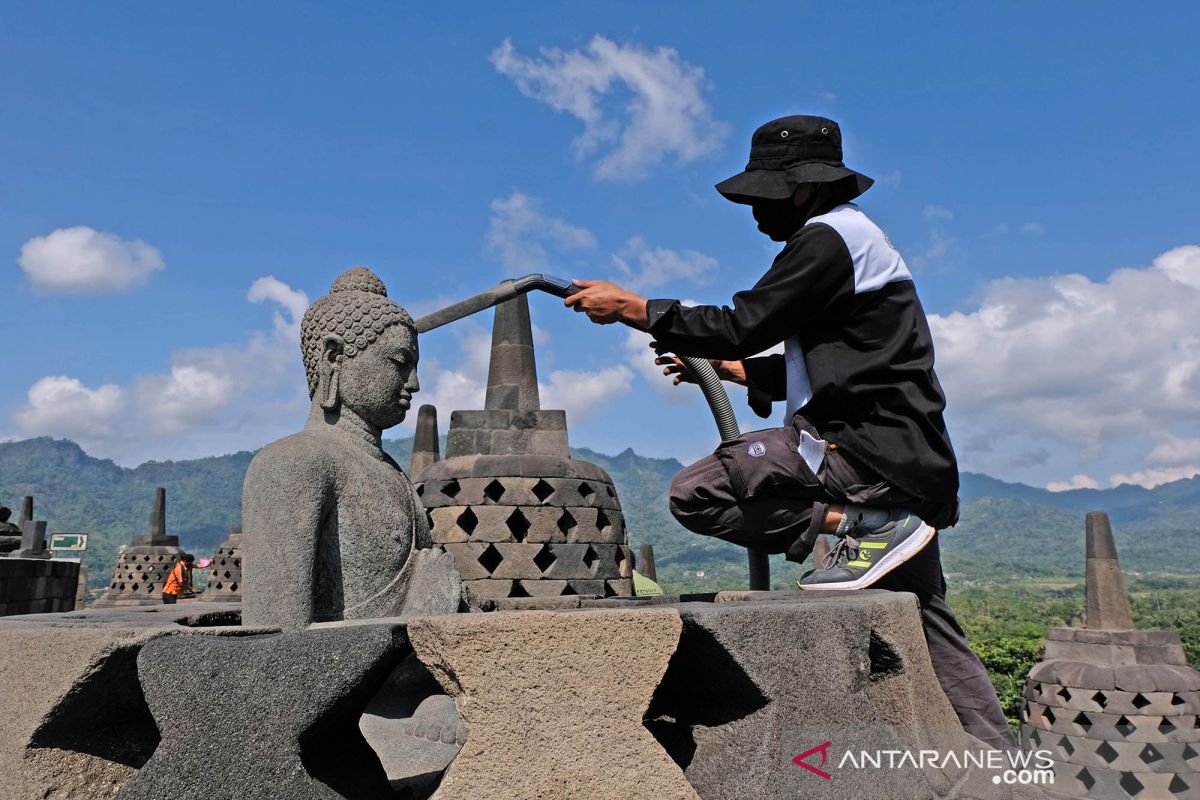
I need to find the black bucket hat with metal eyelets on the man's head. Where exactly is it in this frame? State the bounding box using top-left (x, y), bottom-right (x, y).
top-left (716, 115), bottom-right (875, 205)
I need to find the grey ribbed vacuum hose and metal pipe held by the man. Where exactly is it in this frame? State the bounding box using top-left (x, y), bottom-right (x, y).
top-left (415, 272), bottom-right (770, 590)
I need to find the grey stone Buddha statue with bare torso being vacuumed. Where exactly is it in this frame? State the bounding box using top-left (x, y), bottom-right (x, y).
top-left (242, 267), bottom-right (434, 627)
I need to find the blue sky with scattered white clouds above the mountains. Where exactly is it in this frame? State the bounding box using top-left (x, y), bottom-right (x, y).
top-left (0, 2), bottom-right (1200, 487)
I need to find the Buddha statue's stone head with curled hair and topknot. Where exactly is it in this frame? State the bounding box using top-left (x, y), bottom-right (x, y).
top-left (300, 266), bottom-right (420, 431)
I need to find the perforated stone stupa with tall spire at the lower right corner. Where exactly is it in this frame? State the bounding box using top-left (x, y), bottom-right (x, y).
top-left (1021, 511), bottom-right (1200, 800)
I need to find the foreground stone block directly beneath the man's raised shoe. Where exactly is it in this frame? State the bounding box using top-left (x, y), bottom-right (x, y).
top-left (647, 590), bottom-right (988, 800)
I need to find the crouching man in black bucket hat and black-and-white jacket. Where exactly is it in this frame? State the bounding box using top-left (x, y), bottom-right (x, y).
top-left (565, 116), bottom-right (1012, 747)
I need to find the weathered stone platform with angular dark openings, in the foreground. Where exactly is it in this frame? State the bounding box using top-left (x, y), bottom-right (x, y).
top-left (0, 591), bottom-right (1040, 800)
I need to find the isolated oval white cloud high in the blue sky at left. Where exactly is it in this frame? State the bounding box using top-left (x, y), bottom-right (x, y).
top-left (17, 225), bottom-right (164, 294)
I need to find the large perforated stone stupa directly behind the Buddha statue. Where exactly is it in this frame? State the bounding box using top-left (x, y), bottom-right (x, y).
top-left (419, 295), bottom-right (632, 601)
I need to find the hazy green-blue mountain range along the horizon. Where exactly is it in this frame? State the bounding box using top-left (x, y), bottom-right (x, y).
top-left (0, 438), bottom-right (1200, 590)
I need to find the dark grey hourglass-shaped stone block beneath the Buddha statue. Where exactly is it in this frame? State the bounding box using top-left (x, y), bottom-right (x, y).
top-left (116, 618), bottom-right (408, 800)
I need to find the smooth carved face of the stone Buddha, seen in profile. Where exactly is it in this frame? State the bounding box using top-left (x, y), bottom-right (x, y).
top-left (326, 325), bottom-right (421, 431)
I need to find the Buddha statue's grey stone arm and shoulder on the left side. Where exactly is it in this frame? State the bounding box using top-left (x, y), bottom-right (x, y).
top-left (242, 448), bottom-right (332, 628)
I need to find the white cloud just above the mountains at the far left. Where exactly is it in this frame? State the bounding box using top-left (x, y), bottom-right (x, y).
top-left (12, 375), bottom-right (128, 444)
